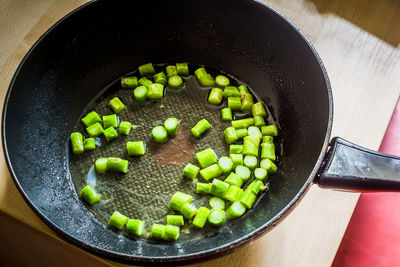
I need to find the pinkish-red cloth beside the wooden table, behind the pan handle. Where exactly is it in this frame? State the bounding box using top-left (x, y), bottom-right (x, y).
top-left (332, 102), bottom-right (400, 267)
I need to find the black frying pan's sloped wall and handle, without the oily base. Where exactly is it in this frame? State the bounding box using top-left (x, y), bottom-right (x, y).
top-left (2, 0), bottom-right (400, 264)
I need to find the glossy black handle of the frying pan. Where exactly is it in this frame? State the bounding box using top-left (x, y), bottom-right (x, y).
top-left (315, 137), bottom-right (400, 192)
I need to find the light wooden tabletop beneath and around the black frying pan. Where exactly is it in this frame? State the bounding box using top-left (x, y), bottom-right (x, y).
top-left (0, 0), bottom-right (400, 266)
